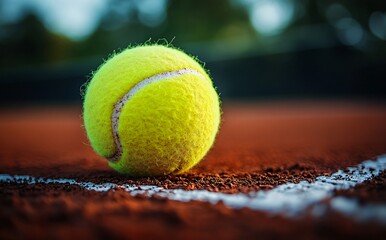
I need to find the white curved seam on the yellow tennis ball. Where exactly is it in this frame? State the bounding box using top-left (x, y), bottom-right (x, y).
top-left (107, 68), bottom-right (206, 162)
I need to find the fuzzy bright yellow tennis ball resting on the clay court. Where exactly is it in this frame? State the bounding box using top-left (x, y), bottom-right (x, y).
top-left (83, 45), bottom-right (221, 176)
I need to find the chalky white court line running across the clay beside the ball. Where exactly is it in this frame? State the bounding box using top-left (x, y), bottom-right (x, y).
top-left (0, 155), bottom-right (386, 224)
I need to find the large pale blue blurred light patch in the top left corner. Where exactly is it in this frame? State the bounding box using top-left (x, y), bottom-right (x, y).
top-left (0, 0), bottom-right (108, 40)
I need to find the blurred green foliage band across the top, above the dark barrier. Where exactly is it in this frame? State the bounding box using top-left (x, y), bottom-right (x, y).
top-left (0, 0), bottom-right (386, 69)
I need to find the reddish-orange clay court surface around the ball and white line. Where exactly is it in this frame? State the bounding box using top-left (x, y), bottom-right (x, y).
top-left (0, 101), bottom-right (386, 239)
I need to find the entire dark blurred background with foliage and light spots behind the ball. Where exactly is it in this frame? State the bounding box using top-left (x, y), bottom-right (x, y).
top-left (0, 0), bottom-right (386, 107)
